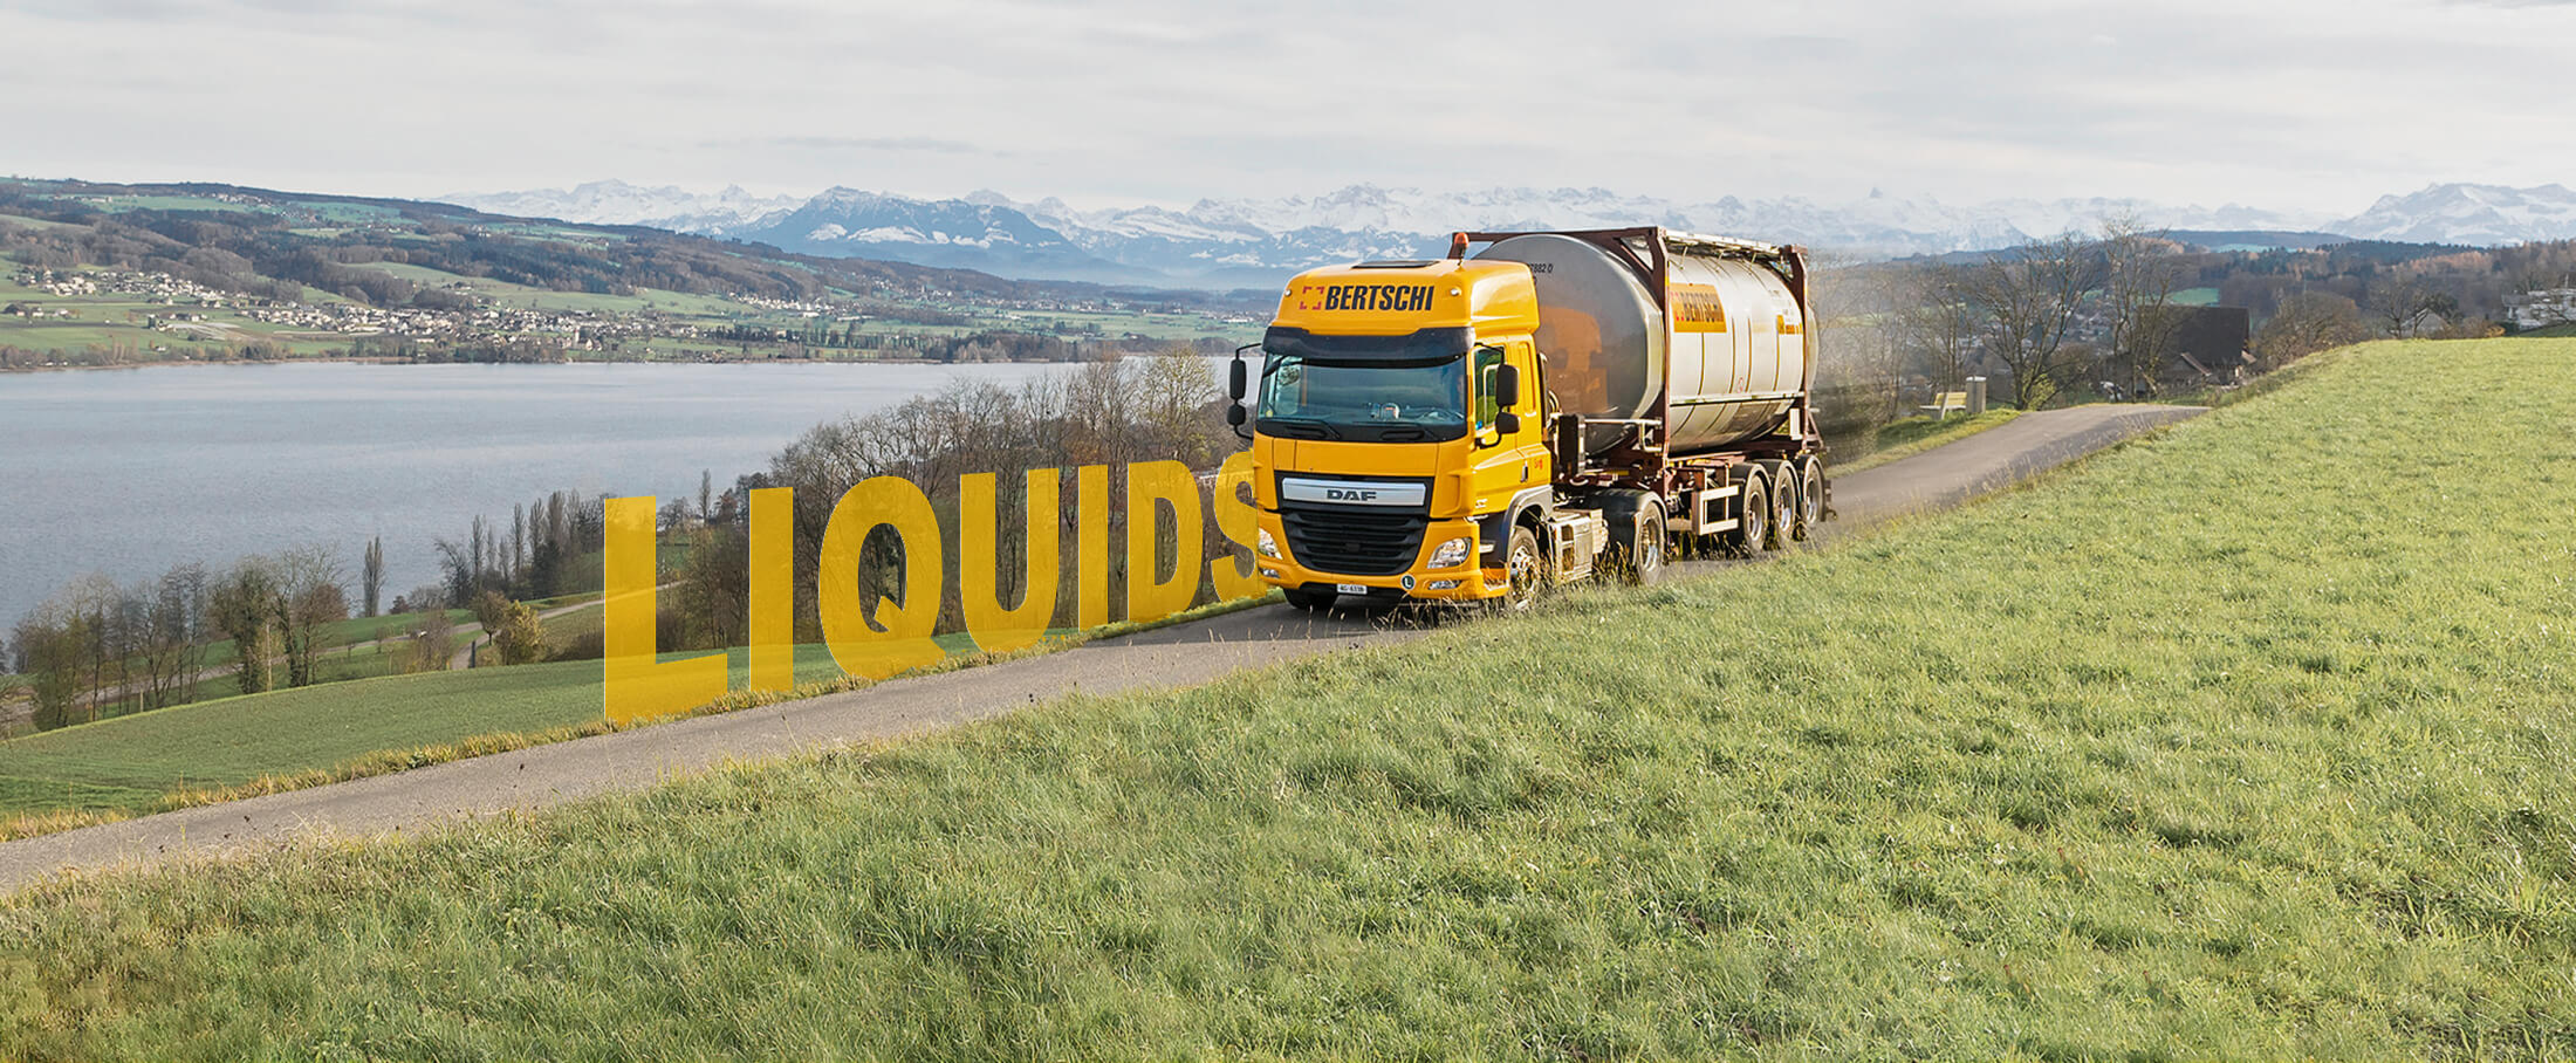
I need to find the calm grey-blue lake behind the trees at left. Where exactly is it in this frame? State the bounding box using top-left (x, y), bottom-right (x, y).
top-left (0, 363), bottom-right (1128, 633)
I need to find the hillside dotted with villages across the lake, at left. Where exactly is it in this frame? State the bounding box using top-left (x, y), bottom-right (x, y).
top-left (0, 180), bottom-right (1265, 368)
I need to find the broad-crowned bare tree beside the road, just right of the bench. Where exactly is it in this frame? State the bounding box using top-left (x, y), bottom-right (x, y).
top-left (1968, 232), bottom-right (2102, 409)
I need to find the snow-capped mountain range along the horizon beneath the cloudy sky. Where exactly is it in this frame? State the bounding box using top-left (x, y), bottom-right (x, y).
top-left (443, 180), bottom-right (2576, 288)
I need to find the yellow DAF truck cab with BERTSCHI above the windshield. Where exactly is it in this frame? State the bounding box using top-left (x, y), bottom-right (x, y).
top-left (1231, 258), bottom-right (1553, 607)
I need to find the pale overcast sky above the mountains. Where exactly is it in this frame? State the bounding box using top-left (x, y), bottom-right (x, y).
top-left (0, 0), bottom-right (2576, 214)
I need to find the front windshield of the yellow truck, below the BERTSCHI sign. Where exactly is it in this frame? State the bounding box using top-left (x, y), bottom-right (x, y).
top-left (1257, 352), bottom-right (1466, 443)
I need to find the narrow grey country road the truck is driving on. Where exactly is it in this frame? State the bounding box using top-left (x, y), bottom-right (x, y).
top-left (0, 407), bottom-right (2200, 893)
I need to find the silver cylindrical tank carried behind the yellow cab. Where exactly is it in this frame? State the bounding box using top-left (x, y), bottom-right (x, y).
top-left (1476, 234), bottom-right (1808, 456)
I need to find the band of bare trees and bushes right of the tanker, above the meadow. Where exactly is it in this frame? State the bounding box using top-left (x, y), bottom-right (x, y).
top-left (1816, 219), bottom-right (2576, 435)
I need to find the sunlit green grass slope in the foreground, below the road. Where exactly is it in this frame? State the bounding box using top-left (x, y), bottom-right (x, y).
top-left (0, 340), bottom-right (2576, 1058)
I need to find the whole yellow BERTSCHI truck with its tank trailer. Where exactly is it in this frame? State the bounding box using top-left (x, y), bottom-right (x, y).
top-left (1229, 227), bottom-right (1829, 610)
